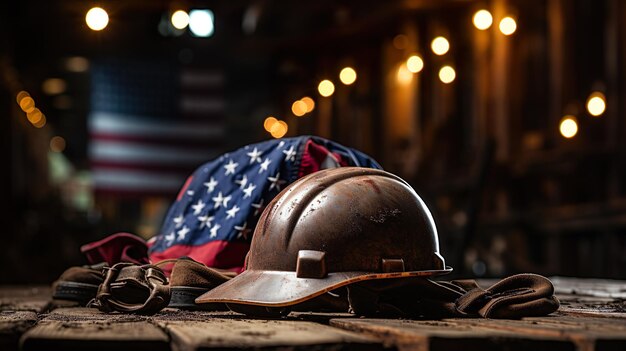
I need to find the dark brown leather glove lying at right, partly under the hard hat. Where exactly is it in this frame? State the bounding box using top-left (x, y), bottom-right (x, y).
top-left (347, 274), bottom-right (559, 319)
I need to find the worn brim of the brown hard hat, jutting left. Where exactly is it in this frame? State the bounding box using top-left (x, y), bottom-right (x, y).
top-left (196, 267), bottom-right (452, 307)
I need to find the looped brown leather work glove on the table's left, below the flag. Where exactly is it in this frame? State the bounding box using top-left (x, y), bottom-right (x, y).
top-left (88, 262), bottom-right (170, 314)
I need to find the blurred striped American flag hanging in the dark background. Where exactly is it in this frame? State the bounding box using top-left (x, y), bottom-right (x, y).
top-left (88, 60), bottom-right (225, 196)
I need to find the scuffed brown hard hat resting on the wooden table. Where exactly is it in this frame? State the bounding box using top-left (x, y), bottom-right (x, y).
top-left (196, 167), bottom-right (452, 307)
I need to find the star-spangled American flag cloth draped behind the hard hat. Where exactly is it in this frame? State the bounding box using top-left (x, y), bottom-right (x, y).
top-left (149, 136), bottom-right (381, 272)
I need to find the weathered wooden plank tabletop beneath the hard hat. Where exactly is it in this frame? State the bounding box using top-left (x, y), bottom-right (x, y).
top-left (0, 277), bottom-right (626, 351)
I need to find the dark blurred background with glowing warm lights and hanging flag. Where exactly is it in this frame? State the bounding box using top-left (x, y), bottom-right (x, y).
top-left (0, 0), bottom-right (626, 283)
